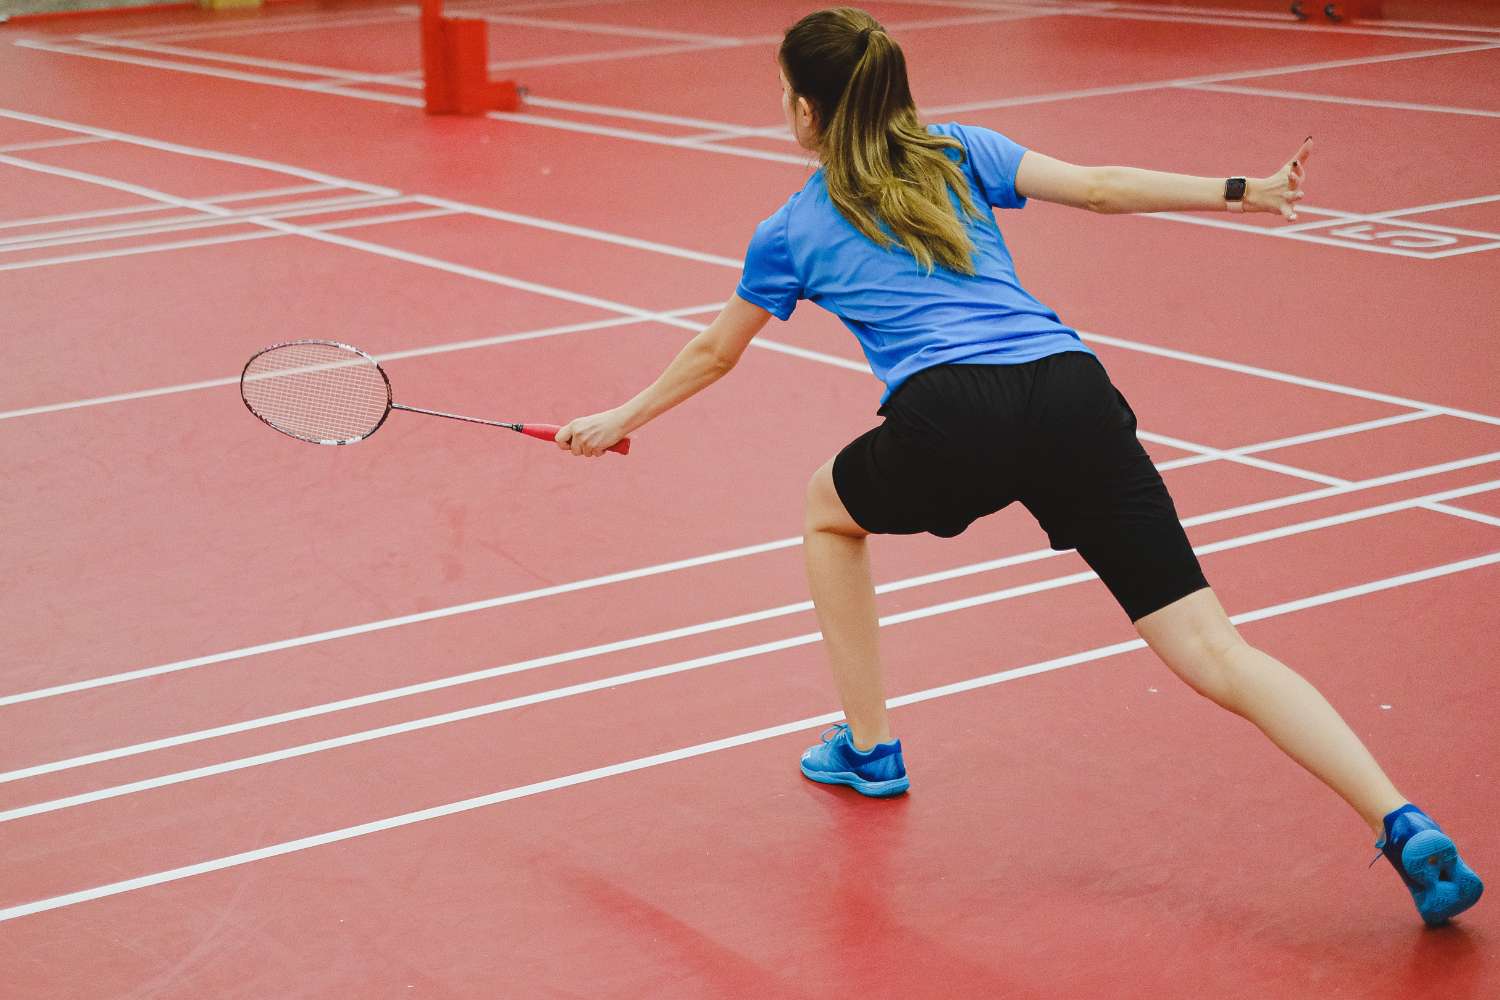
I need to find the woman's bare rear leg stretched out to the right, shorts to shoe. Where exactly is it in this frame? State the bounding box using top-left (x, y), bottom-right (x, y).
top-left (1136, 589), bottom-right (1407, 837)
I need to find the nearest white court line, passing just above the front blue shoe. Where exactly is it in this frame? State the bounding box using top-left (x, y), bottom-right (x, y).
top-left (0, 553), bottom-right (1500, 922)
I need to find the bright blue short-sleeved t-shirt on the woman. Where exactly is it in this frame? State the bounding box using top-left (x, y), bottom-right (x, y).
top-left (737, 124), bottom-right (1089, 403)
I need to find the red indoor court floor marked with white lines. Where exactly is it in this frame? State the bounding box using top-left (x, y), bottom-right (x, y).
top-left (0, 0), bottom-right (1500, 1000)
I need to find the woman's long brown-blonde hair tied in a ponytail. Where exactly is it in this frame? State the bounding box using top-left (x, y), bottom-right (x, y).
top-left (779, 7), bottom-right (980, 274)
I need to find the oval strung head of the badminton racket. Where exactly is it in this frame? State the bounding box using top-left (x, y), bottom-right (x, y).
top-left (240, 343), bottom-right (390, 442)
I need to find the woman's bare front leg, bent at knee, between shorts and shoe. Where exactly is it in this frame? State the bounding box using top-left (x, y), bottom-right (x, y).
top-left (803, 462), bottom-right (891, 750)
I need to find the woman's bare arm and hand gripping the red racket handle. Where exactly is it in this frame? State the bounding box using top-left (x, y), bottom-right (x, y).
top-left (557, 295), bottom-right (771, 457)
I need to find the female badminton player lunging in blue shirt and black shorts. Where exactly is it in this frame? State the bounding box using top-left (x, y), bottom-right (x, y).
top-left (557, 7), bottom-right (1484, 924)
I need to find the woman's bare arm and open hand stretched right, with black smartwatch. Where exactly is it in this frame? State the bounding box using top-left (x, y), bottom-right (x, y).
top-left (1016, 136), bottom-right (1313, 219)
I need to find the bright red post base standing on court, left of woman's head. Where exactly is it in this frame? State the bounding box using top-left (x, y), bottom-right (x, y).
top-left (422, 0), bottom-right (521, 114)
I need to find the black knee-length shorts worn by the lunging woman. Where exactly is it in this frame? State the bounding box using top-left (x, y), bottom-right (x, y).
top-left (834, 351), bottom-right (1208, 621)
